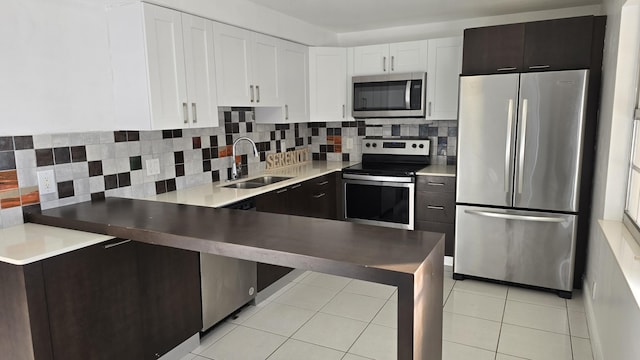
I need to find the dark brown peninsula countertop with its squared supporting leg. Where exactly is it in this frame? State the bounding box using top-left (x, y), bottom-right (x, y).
top-left (27, 198), bottom-right (444, 360)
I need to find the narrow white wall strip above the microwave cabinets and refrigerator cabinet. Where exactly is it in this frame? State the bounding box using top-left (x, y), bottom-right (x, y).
top-left (338, 5), bottom-right (602, 46)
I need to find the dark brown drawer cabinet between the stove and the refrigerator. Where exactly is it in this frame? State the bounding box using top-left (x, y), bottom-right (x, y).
top-left (415, 176), bottom-right (456, 256)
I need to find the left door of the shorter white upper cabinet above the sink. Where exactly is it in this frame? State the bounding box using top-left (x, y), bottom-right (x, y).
top-left (213, 23), bottom-right (255, 106)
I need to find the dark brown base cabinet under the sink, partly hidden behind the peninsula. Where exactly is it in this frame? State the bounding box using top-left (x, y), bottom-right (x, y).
top-left (256, 172), bottom-right (341, 291)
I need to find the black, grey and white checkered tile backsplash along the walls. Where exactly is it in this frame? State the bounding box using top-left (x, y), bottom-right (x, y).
top-left (0, 108), bottom-right (457, 228)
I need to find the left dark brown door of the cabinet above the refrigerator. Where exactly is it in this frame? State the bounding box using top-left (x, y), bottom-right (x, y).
top-left (462, 24), bottom-right (525, 75)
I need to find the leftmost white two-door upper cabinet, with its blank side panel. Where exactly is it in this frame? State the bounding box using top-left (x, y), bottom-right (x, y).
top-left (109, 3), bottom-right (218, 130)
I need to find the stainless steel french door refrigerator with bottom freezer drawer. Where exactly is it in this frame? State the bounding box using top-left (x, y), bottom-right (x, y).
top-left (454, 70), bottom-right (588, 297)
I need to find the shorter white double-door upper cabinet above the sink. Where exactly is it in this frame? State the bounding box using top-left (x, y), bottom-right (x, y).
top-left (214, 23), bottom-right (281, 106)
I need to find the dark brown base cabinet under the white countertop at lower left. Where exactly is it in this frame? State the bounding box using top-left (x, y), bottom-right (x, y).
top-left (0, 239), bottom-right (201, 360)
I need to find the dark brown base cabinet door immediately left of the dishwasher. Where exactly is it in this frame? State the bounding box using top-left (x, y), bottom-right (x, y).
top-left (136, 243), bottom-right (202, 359)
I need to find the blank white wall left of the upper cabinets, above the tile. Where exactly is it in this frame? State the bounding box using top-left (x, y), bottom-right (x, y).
top-left (0, 0), bottom-right (113, 135)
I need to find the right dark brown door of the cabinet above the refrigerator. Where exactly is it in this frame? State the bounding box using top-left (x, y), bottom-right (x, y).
top-left (524, 16), bottom-right (594, 71)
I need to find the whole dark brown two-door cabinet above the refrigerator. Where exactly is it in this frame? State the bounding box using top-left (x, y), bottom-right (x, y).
top-left (462, 16), bottom-right (604, 75)
